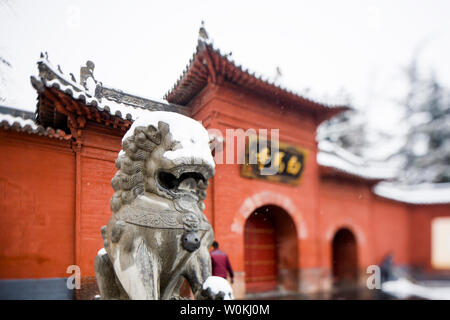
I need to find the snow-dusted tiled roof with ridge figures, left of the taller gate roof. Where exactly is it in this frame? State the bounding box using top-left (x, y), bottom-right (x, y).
top-left (31, 58), bottom-right (188, 130)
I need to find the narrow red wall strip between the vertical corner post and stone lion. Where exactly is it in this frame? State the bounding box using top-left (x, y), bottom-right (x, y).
top-left (76, 124), bottom-right (122, 276)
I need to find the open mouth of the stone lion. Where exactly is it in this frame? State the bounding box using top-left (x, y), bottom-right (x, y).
top-left (156, 167), bottom-right (208, 199)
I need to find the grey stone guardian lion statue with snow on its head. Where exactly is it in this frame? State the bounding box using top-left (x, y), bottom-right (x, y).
top-left (95, 111), bottom-right (227, 299)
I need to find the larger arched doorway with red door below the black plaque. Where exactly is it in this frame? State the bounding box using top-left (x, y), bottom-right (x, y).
top-left (244, 205), bottom-right (298, 293)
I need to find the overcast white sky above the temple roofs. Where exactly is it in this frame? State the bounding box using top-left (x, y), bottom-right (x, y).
top-left (0, 0), bottom-right (450, 140)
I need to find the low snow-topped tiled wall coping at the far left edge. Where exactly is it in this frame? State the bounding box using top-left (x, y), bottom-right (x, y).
top-left (0, 113), bottom-right (71, 140)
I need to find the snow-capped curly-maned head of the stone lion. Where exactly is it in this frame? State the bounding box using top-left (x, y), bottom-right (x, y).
top-left (111, 111), bottom-right (214, 212)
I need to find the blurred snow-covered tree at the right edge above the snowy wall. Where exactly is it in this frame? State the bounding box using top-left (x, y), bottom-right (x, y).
top-left (398, 59), bottom-right (450, 184)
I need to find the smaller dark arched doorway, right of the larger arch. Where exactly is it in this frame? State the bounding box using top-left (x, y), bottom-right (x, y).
top-left (332, 228), bottom-right (358, 287)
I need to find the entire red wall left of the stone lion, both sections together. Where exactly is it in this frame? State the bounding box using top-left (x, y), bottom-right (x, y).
top-left (0, 124), bottom-right (122, 278)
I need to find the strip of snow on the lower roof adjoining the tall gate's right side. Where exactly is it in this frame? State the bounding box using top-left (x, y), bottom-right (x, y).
top-left (317, 141), bottom-right (397, 180)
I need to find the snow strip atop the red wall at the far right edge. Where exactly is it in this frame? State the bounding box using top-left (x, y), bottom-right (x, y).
top-left (373, 182), bottom-right (450, 204)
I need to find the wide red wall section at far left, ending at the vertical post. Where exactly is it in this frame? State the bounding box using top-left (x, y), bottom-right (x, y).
top-left (0, 130), bottom-right (75, 279)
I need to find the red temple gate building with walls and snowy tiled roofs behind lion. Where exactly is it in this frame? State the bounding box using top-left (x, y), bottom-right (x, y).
top-left (0, 33), bottom-right (450, 298)
